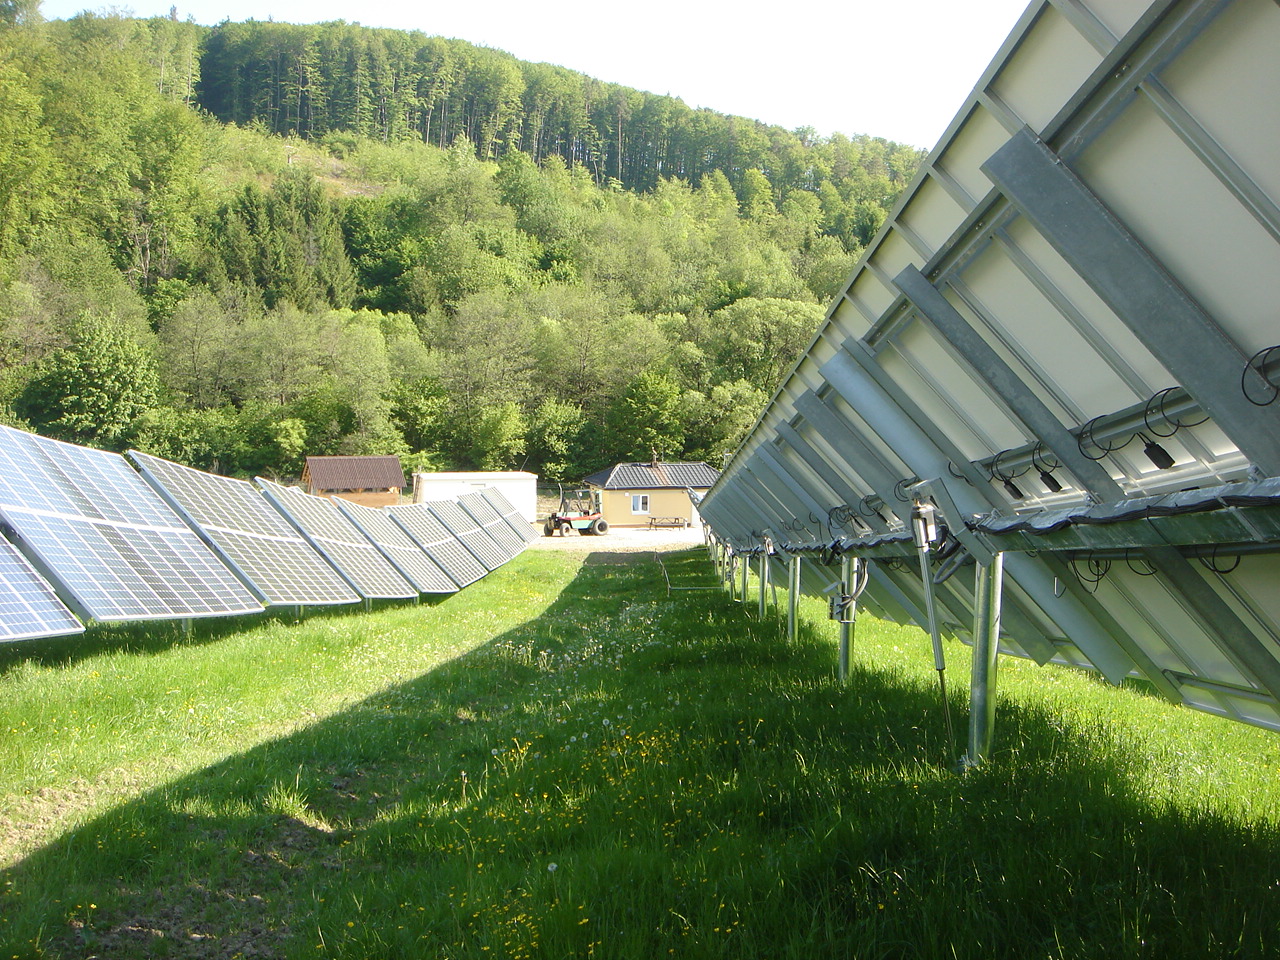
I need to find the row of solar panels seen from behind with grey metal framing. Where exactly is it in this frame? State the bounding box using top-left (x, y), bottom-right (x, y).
top-left (700, 0), bottom-right (1280, 730)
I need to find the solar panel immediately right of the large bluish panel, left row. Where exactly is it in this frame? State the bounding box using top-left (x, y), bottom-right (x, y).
top-left (129, 451), bottom-right (360, 605)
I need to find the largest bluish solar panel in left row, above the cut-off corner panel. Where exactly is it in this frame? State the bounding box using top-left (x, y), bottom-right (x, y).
top-left (0, 428), bottom-right (262, 631)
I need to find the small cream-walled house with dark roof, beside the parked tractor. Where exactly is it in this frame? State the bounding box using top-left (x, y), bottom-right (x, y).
top-left (582, 461), bottom-right (719, 527)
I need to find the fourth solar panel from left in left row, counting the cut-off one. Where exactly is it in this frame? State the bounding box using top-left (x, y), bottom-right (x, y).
top-left (257, 477), bottom-right (419, 599)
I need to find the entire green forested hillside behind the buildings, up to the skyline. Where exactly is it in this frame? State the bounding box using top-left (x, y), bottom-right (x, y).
top-left (0, 0), bottom-right (919, 479)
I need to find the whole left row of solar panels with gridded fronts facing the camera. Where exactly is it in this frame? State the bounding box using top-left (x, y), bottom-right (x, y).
top-left (0, 428), bottom-right (536, 640)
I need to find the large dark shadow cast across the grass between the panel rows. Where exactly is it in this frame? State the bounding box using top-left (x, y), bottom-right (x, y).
top-left (0, 552), bottom-right (1280, 959)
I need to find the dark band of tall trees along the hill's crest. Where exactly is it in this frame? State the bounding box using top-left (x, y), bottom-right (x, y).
top-left (198, 22), bottom-right (919, 202)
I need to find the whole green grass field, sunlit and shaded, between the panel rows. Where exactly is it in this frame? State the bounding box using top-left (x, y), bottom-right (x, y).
top-left (0, 552), bottom-right (1280, 960)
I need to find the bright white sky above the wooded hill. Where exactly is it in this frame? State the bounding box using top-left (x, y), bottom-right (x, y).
top-left (41, 0), bottom-right (1028, 148)
